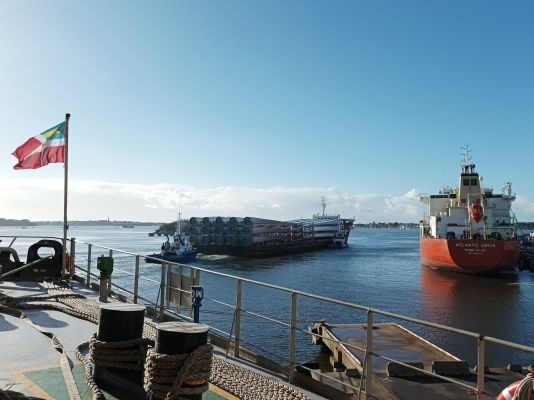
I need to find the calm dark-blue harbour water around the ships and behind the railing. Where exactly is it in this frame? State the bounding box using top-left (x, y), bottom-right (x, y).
top-left (0, 227), bottom-right (534, 366)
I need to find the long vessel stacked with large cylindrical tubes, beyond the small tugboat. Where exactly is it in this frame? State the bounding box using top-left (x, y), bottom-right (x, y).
top-left (188, 203), bottom-right (354, 256)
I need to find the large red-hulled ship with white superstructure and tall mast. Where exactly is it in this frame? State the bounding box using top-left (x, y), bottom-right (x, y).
top-left (419, 145), bottom-right (521, 273)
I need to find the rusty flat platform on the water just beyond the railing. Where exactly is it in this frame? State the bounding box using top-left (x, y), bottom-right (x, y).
top-left (302, 323), bottom-right (524, 400)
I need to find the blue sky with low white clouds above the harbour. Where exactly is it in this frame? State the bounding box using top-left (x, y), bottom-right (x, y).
top-left (0, 0), bottom-right (534, 223)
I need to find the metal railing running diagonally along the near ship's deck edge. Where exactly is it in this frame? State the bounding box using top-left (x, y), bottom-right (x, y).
top-left (0, 236), bottom-right (534, 399)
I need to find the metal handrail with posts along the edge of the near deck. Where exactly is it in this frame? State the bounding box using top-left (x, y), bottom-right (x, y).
top-left (0, 235), bottom-right (534, 398)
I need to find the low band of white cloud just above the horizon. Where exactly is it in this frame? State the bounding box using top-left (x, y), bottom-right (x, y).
top-left (6, 179), bottom-right (534, 223)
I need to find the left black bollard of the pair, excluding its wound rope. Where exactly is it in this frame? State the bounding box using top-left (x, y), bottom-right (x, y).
top-left (93, 303), bottom-right (146, 400)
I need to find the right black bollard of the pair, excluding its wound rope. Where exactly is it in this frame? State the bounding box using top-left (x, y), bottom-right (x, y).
top-left (154, 322), bottom-right (209, 400)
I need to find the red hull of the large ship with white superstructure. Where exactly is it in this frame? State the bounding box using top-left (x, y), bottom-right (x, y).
top-left (420, 238), bottom-right (520, 273)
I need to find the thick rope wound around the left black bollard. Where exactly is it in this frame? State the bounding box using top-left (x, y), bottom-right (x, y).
top-left (89, 334), bottom-right (154, 371)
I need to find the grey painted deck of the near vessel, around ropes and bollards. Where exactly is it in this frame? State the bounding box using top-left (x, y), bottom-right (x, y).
top-left (0, 281), bottom-right (324, 400)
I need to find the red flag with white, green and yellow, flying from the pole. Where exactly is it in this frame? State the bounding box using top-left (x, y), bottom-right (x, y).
top-left (11, 122), bottom-right (65, 169)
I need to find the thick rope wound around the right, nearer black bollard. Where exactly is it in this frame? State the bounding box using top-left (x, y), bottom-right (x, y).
top-left (144, 344), bottom-right (213, 400)
